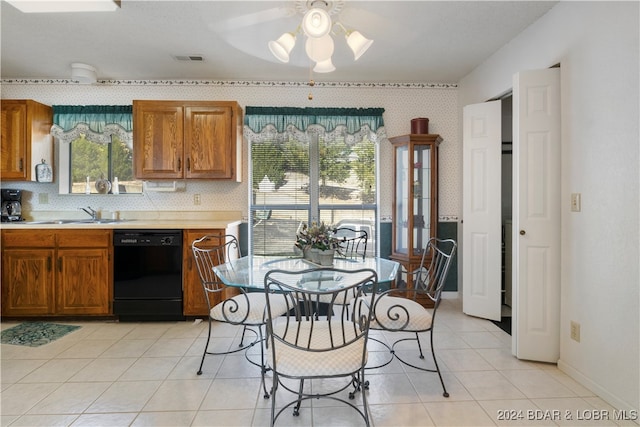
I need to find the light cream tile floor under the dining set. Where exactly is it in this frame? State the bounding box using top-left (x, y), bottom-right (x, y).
top-left (0, 300), bottom-right (638, 427)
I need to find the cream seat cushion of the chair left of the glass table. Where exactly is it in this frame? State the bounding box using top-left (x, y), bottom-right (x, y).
top-left (209, 292), bottom-right (287, 325)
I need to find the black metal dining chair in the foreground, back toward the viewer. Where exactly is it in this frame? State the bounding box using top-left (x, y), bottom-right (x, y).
top-left (264, 267), bottom-right (378, 426)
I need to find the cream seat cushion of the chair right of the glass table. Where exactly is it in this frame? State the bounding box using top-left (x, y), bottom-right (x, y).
top-left (370, 295), bottom-right (432, 332)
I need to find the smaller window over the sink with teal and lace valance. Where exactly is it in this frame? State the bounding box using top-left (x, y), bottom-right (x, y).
top-left (51, 105), bottom-right (142, 194)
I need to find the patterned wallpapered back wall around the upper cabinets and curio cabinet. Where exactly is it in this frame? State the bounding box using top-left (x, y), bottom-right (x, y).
top-left (1, 79), bottom-right (462, 220)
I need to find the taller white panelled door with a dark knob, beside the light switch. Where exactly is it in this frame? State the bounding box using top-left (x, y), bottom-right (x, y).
top-left (510, 68), bottom-right (560, 363)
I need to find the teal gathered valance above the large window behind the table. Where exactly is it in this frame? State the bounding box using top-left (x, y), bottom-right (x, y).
top-left (245, 107), bottom-right (384, 134)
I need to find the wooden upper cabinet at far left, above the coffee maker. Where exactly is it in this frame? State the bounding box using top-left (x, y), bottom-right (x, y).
top-left (0, 99), bottom-right (53, 181)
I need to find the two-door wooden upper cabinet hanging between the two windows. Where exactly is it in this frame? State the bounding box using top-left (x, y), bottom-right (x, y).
top-left (133, 101), bottom-right (242, 182)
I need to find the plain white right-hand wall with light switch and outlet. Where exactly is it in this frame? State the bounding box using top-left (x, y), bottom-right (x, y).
top-left (458, 1), bottom-right (640, 410)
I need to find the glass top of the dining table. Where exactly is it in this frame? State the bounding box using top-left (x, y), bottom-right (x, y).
top-left (213, 255), bottom-right (400, 290)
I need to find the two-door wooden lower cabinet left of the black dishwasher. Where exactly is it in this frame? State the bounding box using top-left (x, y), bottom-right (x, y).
top-left (2, 229), bottom-right (113, 316)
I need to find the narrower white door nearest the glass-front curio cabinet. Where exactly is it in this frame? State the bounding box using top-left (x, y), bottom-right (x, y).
top-left (462, 101), bottom-right (502, 320)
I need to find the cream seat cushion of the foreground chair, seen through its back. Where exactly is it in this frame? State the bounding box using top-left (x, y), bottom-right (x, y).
top-left (268, 321), bottom-right (367, 377)
